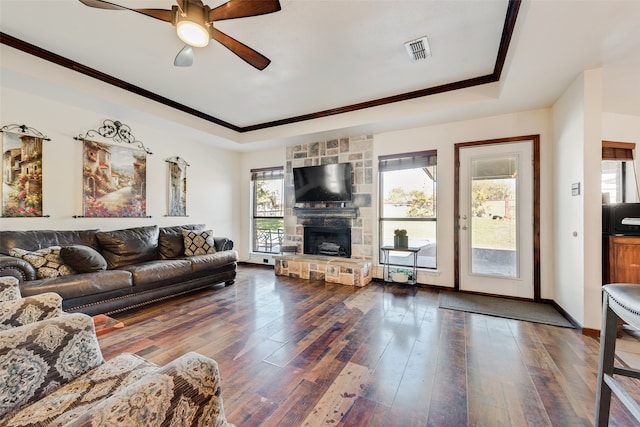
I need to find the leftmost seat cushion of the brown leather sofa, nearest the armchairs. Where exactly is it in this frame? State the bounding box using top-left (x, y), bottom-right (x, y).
top-left (20, 270), bottom-right (132, 299)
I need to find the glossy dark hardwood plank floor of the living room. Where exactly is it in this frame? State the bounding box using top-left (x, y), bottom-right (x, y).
top-left (100, 266), bottom-right (640, 427)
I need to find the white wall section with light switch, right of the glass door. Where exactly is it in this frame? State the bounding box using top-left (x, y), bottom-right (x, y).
top-left (552, 69), bottom-right (604, 329)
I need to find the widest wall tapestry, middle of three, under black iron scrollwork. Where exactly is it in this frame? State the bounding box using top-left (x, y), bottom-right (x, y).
top-left (76, 120), bottom-right (151, 217)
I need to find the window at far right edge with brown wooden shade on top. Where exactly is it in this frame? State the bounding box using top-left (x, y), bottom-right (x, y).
top-left (601, 141), bottom-right (638, 204)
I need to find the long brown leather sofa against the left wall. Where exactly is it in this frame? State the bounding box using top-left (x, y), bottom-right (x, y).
top-left (0, 224), bottom-right (238, 315)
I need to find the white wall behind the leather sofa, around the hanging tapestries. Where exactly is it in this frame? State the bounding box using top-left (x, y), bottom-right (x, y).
top-left (0, 86), bottom-right (240, 239)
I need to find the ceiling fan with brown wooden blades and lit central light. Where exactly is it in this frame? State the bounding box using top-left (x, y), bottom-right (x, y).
top-left (80, 0), bottom-right (280, 70)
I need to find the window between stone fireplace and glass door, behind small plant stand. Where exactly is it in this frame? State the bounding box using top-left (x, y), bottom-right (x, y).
top-left (378, 151), bottom-right (437, 268)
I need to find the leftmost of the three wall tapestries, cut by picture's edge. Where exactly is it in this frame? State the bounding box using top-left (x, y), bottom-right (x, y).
top-left (0, 125), bottom-right (50, 218)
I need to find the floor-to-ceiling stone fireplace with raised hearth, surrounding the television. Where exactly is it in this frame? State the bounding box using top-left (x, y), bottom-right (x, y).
top-left (274, 135), bottom-right (376, 286)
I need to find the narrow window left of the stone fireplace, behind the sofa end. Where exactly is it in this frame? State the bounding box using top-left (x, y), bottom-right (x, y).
top-left (251, 167), bottom-right (284, 253)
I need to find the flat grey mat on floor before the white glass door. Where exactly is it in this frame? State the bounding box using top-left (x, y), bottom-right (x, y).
top-left (440, 292), bottom-right (574, 328)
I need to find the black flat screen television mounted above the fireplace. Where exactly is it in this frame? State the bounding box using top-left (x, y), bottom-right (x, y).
top-left (293, 163), bottom-right (351, 203)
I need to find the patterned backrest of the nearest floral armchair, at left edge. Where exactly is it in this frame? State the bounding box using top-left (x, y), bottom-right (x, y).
top-left (0, 314), bottom-right (104, 420)
